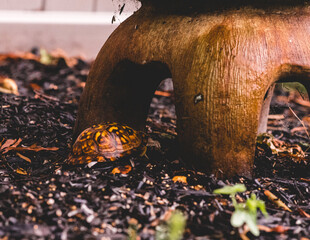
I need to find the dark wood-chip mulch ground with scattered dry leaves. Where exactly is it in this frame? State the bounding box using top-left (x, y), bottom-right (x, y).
top-left (0, 51), bottom-right (310, 240)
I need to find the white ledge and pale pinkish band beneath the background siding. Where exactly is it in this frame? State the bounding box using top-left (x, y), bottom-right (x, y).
top-left (0, 4), bottom-right (138, 59)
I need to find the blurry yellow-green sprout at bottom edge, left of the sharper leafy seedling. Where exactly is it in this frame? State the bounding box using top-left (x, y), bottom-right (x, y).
top-left (155, 211), bottom-right (186, 240)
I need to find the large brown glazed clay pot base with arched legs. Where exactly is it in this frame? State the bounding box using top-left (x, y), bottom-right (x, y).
top-left (74, 0), bottom-right (310, 177)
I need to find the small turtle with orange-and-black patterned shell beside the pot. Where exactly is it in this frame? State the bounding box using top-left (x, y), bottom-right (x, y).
top-left (68, 123), bottom-right (147, 164)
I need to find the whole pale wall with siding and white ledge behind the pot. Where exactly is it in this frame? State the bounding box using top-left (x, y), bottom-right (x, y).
top-left (0, 0), bottom-right (140, 59)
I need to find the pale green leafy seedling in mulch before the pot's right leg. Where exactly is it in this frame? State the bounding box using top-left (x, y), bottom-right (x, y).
top-left (214, 184), bottom-right (268, 236)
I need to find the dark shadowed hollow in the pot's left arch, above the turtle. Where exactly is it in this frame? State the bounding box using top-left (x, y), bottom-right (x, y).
top-left (96, 60), bottom-right (171, 130)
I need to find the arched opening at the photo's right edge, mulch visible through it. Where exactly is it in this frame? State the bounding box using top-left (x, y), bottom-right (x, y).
top-left (255, 68), bottom-right (310, 177)
